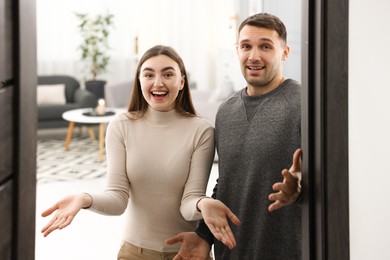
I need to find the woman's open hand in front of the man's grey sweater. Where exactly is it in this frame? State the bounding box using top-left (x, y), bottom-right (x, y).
top-left (198, 198), bottom-right (240, 249)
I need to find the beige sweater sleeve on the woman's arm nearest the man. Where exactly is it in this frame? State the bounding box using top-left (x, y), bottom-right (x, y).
top-left (180, 123), bottom-right (215, 221)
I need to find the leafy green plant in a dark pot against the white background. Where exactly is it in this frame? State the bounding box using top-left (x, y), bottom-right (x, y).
top-left (76, 13), bottom-right (114, 98)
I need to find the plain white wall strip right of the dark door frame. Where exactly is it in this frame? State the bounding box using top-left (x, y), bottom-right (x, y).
top-left (349, 0), bottom-right (390, 260)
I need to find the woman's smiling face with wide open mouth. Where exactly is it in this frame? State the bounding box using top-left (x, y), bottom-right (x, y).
top-left (139, 55), bottom-right (185, 112)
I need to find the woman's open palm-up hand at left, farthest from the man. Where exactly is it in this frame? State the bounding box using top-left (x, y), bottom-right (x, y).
top-left (41, 194), bottom-right (92, 237)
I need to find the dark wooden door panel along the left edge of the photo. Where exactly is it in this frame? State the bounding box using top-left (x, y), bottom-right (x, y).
top-left (0, 0), bottom-right (37, 260)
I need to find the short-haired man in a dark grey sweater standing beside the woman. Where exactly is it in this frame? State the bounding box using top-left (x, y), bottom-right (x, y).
top-left (167, 13), bottom-right (301, 260)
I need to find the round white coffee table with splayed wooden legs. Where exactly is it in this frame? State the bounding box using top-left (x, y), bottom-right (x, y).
top-left (62, 108), bottom-right (126, 161)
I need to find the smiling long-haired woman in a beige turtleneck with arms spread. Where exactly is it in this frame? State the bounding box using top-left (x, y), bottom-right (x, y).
top-left (42, 45), bottom-right (238, 259)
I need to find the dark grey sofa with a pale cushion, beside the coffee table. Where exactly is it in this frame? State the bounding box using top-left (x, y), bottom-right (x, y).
top-left (37, 75), bottom-right (97, 129)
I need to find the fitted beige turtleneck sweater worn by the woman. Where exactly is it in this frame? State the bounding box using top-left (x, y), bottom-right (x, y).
top-left (90, 109), bottom-right (214, 252)
